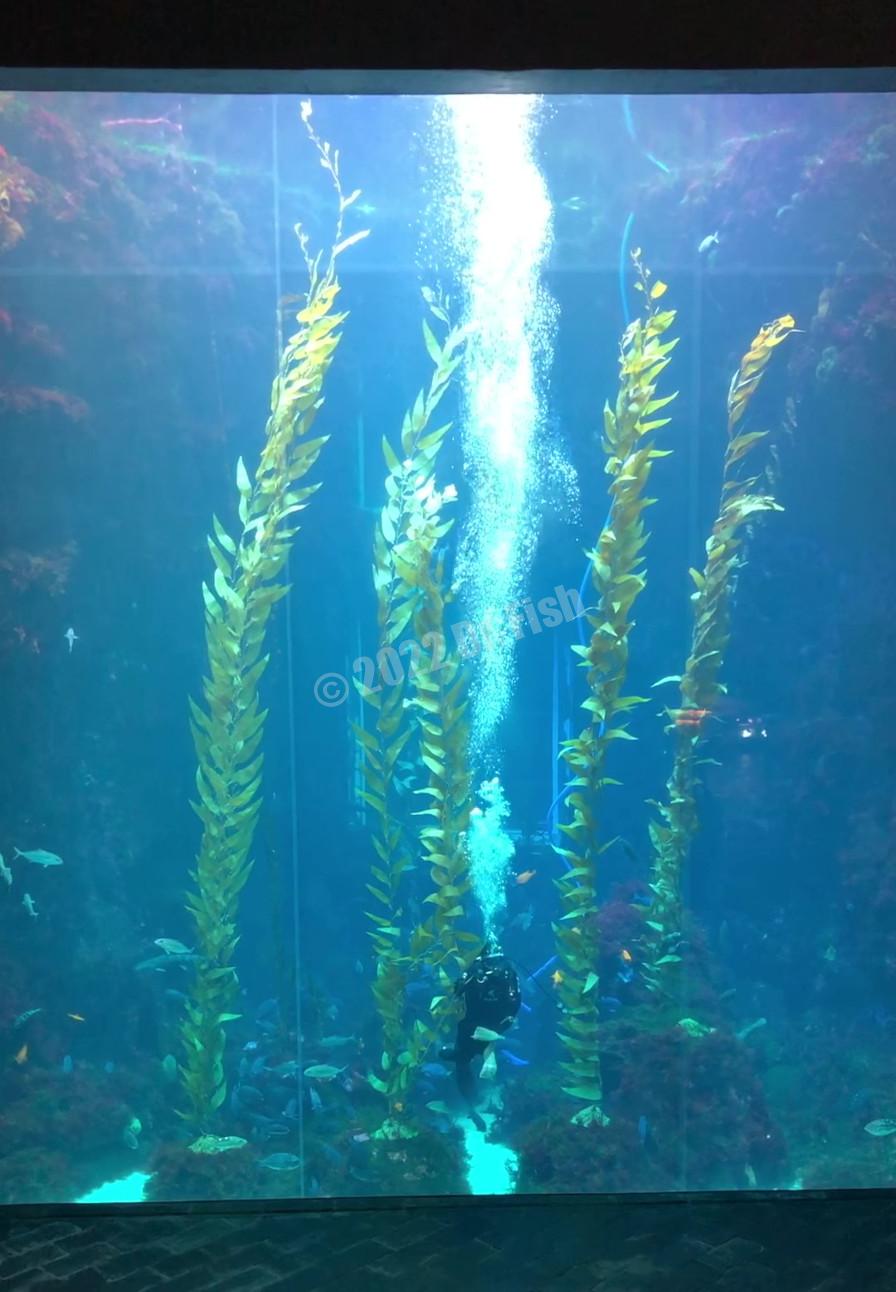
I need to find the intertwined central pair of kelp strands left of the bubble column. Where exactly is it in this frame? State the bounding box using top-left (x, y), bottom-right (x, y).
top-left (354, 289), bottom-right (469, 1124)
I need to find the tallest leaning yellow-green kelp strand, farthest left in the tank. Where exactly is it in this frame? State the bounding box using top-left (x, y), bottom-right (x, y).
top-left (181, 121), bottom-right (357, 1129)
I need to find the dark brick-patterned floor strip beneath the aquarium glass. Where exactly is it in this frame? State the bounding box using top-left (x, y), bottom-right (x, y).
top-left (0, 1194), bottom-right (896, 1292)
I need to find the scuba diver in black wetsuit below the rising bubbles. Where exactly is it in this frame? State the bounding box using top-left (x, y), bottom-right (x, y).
top-left (440, 947), bottom-right (522, 1131)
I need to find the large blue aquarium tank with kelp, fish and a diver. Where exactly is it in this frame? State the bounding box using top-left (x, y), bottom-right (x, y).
top-left (0, 75), bottom-right (896, 1204)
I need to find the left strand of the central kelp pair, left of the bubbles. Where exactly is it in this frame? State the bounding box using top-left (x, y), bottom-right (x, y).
top-left (354, 289), bottom-right (464, 1128)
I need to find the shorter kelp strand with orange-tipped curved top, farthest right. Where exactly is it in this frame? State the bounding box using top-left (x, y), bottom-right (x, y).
top-left (644, 314), bottom-right (795, 995)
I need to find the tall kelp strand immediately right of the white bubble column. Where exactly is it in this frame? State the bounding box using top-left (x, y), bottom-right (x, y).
top-left (553, 251), bottom-right (676, 1125)
